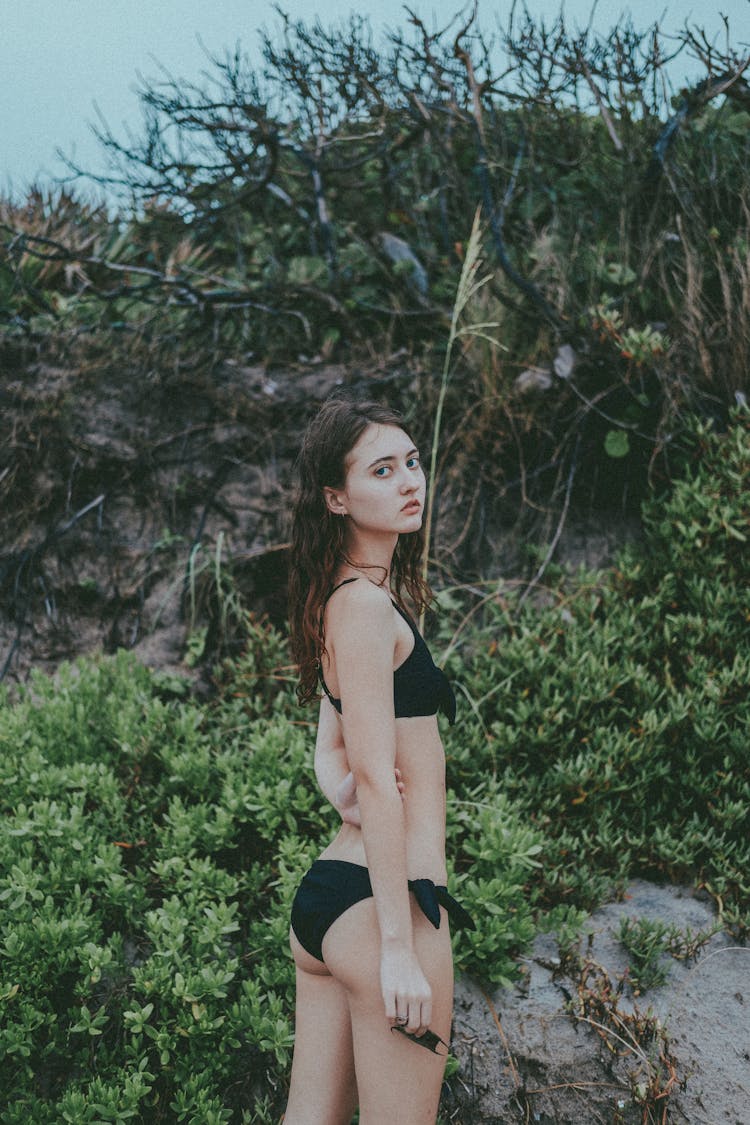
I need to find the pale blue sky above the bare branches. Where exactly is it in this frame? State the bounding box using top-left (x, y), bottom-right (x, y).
top-left (0, 0), bottom-right (750, 196)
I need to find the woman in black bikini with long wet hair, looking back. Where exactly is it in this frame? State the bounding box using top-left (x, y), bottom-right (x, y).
top-left (284, 398), bottom-right (471, 1125)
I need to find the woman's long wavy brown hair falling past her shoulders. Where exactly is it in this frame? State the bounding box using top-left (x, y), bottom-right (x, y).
top-left (289, 396), bottom-right (432, 703)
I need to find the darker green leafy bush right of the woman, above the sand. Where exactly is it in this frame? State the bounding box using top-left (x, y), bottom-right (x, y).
top-left (449, 411), bottom-right (750, 930)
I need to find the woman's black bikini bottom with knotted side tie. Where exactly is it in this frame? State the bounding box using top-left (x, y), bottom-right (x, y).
top-left (291, 860), bottom-right (476, 961)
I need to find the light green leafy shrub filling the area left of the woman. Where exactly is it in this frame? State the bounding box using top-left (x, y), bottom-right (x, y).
top-left (0, 654), bottom-right (308, 1123)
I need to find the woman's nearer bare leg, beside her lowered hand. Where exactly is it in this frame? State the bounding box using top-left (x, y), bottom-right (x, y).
top-left (323, 899), bottom-right (453, 1125)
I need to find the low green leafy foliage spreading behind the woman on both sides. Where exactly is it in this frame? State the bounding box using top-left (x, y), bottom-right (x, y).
top-left (0, 411), bottom-right (750, 1125)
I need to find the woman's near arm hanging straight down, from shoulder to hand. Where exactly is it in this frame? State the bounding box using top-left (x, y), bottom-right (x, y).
top-left (326, 582), bottom-right (432, 1032)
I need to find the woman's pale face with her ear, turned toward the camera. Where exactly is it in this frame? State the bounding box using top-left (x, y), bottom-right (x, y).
top-left (324, 423), bottom-right (426, 534)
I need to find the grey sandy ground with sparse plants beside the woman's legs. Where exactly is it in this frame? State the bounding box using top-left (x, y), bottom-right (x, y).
top-left (449, 882), bottom-right (750, 1125)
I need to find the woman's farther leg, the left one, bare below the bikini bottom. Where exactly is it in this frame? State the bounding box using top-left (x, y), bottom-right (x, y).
top-left (283, 933), bottom-right (356, 1125)
